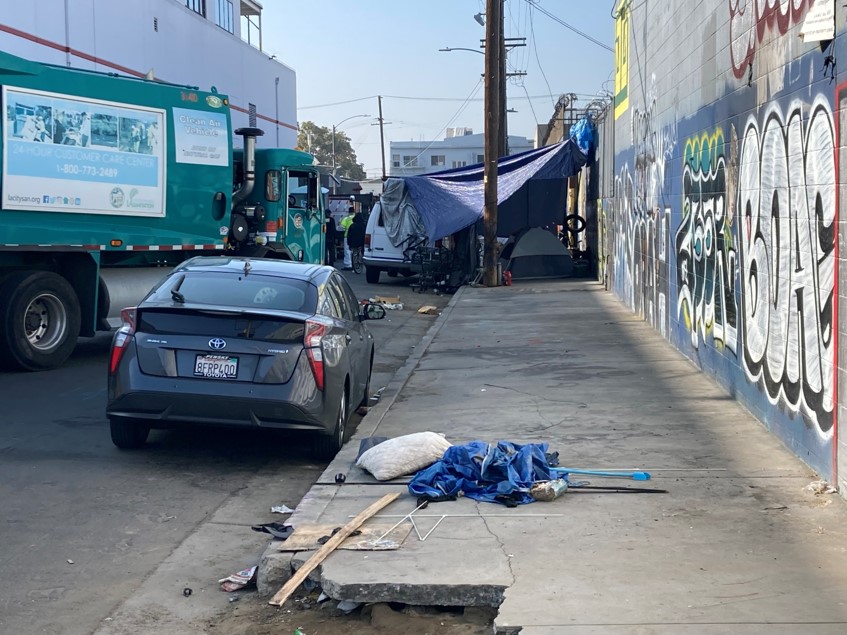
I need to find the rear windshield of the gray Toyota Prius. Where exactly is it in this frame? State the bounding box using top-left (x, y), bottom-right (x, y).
top-left (147, 271), bottom-right (318, 314)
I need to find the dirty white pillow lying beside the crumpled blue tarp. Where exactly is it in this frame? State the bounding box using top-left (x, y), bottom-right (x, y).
top-left (356, 432), bottom-right (452, 481)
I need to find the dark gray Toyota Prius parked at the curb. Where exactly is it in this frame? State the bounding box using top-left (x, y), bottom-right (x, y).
top-left (106, 256), bottom-right (385, 458)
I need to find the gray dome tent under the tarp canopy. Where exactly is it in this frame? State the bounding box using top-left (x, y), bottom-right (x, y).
top-left (500, 227), bottom-right (574, 279)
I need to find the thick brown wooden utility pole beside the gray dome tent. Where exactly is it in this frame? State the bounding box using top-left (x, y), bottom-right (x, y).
top-left (482, 0), bottom-right (504, 287)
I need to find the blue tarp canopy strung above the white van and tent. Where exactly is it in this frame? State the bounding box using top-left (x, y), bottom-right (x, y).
top-left (382, 139), bottom-right (586, 245)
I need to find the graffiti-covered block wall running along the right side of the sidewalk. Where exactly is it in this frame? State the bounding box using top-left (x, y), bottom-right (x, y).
top-left (602, 0), bottom-right (847, 482)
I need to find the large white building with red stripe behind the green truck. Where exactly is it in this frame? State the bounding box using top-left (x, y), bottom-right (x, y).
top-left (0, 0), bottom-right (297, 148)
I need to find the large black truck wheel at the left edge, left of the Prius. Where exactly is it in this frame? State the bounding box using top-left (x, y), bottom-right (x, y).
top-left (0, 271), bottom-right (80, 370)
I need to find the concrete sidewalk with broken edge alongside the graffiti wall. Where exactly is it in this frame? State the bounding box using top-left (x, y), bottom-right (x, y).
top-left (259, 280), bottom-right (847, 635)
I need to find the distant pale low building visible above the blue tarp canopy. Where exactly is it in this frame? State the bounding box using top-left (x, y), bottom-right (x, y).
top-left (389, 128), bottom-right (535, 176)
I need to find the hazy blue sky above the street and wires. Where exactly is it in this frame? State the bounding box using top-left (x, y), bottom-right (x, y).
top-left (262, 0), bottom-right (615, 178)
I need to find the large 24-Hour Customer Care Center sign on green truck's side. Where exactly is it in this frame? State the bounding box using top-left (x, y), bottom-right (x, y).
top-left (0, 86), bottom-right (167, 216)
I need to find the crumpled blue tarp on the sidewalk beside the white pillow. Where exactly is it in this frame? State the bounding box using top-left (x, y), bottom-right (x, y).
top-left (409, 441), bottom-right (552, 504)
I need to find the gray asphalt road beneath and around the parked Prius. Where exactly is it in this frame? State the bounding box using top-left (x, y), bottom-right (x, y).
top-left (0, 274), bottom-right (449, 634)
